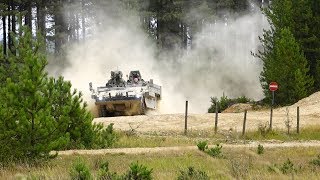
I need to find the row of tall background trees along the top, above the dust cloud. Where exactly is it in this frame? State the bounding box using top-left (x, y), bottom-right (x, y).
top-left (0, 0), bottom-right (267, 54)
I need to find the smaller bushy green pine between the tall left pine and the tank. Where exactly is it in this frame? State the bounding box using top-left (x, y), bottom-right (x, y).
top-left (46, 77), bottom-right (94, 149)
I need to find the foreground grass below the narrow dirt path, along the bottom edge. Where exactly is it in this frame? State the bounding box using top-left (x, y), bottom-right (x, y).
top-left (0, 147), bottom-right (320, 179)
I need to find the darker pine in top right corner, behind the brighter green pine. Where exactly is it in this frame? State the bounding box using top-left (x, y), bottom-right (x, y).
top-left (264, 0), bottom-right (320, 92)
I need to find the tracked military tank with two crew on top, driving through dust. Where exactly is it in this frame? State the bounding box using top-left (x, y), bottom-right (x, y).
top-left (89, 71), bottom-right (161, 117)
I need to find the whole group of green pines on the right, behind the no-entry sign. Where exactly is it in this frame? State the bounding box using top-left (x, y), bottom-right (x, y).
top-left (256, 0), bottom-right (320, 104)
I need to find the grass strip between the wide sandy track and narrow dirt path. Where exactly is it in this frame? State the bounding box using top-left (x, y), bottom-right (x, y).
top-left (114, 126), bottom-right (320, 148)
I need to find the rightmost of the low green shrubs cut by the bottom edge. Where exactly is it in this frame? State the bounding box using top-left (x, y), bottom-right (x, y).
top-left (177, 167), bottom-right (210, 180)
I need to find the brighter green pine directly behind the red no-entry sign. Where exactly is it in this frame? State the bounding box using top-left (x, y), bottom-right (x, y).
top-left (260, 28), bottom-right (313, 104)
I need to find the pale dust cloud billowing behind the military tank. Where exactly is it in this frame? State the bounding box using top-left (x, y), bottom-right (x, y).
top-left (57, 0), bottom-right (264, 114)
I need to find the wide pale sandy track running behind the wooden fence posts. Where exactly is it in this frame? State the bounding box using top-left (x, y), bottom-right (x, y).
top-left (94, 92), bottom-right (320, 133)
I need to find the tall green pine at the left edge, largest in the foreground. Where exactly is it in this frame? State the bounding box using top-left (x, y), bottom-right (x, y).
top-left (0, 29), bottom-right (69, 162)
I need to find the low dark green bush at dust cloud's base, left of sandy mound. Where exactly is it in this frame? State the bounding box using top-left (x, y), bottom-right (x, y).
top-left (208, 94), bottom-right (252, 113)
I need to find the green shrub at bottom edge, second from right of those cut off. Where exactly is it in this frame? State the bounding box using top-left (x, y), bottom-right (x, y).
top-left (122, 163), bottom-right (152, 180)
